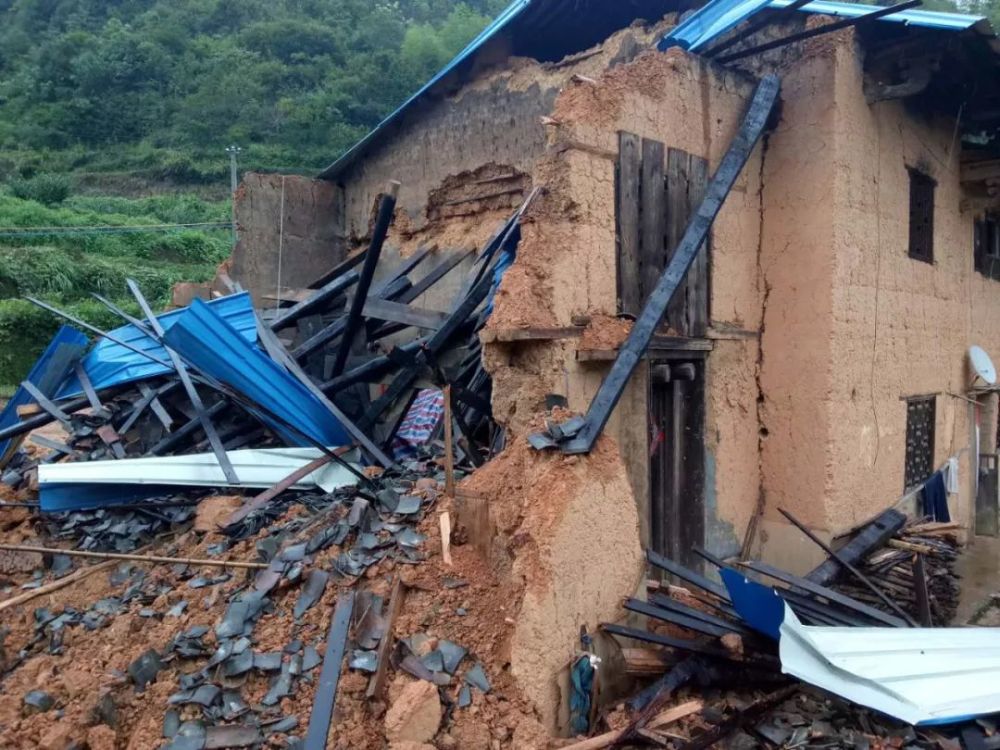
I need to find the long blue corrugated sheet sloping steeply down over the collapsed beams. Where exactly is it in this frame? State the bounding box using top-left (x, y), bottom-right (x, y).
top-left (164, 300), bottom-right (350, 446)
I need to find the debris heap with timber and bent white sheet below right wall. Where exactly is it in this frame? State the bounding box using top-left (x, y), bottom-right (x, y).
top-left (571, 511), bottom-right (984, 750)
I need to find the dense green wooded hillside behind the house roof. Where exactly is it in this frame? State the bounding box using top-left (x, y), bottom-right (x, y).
top-left (0, 0), bottom-right (506, 183)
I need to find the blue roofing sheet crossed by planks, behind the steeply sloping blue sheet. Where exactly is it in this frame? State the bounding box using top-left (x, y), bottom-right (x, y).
top-left (57, 292), bottom-right (257, 398)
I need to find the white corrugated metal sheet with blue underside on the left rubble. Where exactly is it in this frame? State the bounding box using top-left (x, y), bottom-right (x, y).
top-left (38, 448), bottom-right (357, 513)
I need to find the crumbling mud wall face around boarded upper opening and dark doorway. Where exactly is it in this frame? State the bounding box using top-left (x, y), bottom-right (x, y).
top-left (486, 50), bottom-right (761, 551)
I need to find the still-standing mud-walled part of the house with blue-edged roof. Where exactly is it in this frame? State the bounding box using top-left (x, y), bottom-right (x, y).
top-left (232, 3), bottom-right (1000, 568)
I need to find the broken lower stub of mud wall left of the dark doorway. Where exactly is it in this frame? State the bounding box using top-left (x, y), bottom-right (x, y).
top-left (465, 432), bottom-right (643, 733)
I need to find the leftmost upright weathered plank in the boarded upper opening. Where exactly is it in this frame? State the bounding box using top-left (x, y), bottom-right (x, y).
top-left (615, 131), bottom-right (643, 315)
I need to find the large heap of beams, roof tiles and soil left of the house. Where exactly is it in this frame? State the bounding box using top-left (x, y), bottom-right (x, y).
top-left (0, 188), bottom-right (564, 750)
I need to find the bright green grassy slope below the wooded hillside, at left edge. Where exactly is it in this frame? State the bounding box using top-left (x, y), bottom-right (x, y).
top-left (0, 191), bottom-right (231, 388)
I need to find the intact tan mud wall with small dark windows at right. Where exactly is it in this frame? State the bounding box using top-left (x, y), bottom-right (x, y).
top-left (761, 34), bottom-right (1000, 564)
